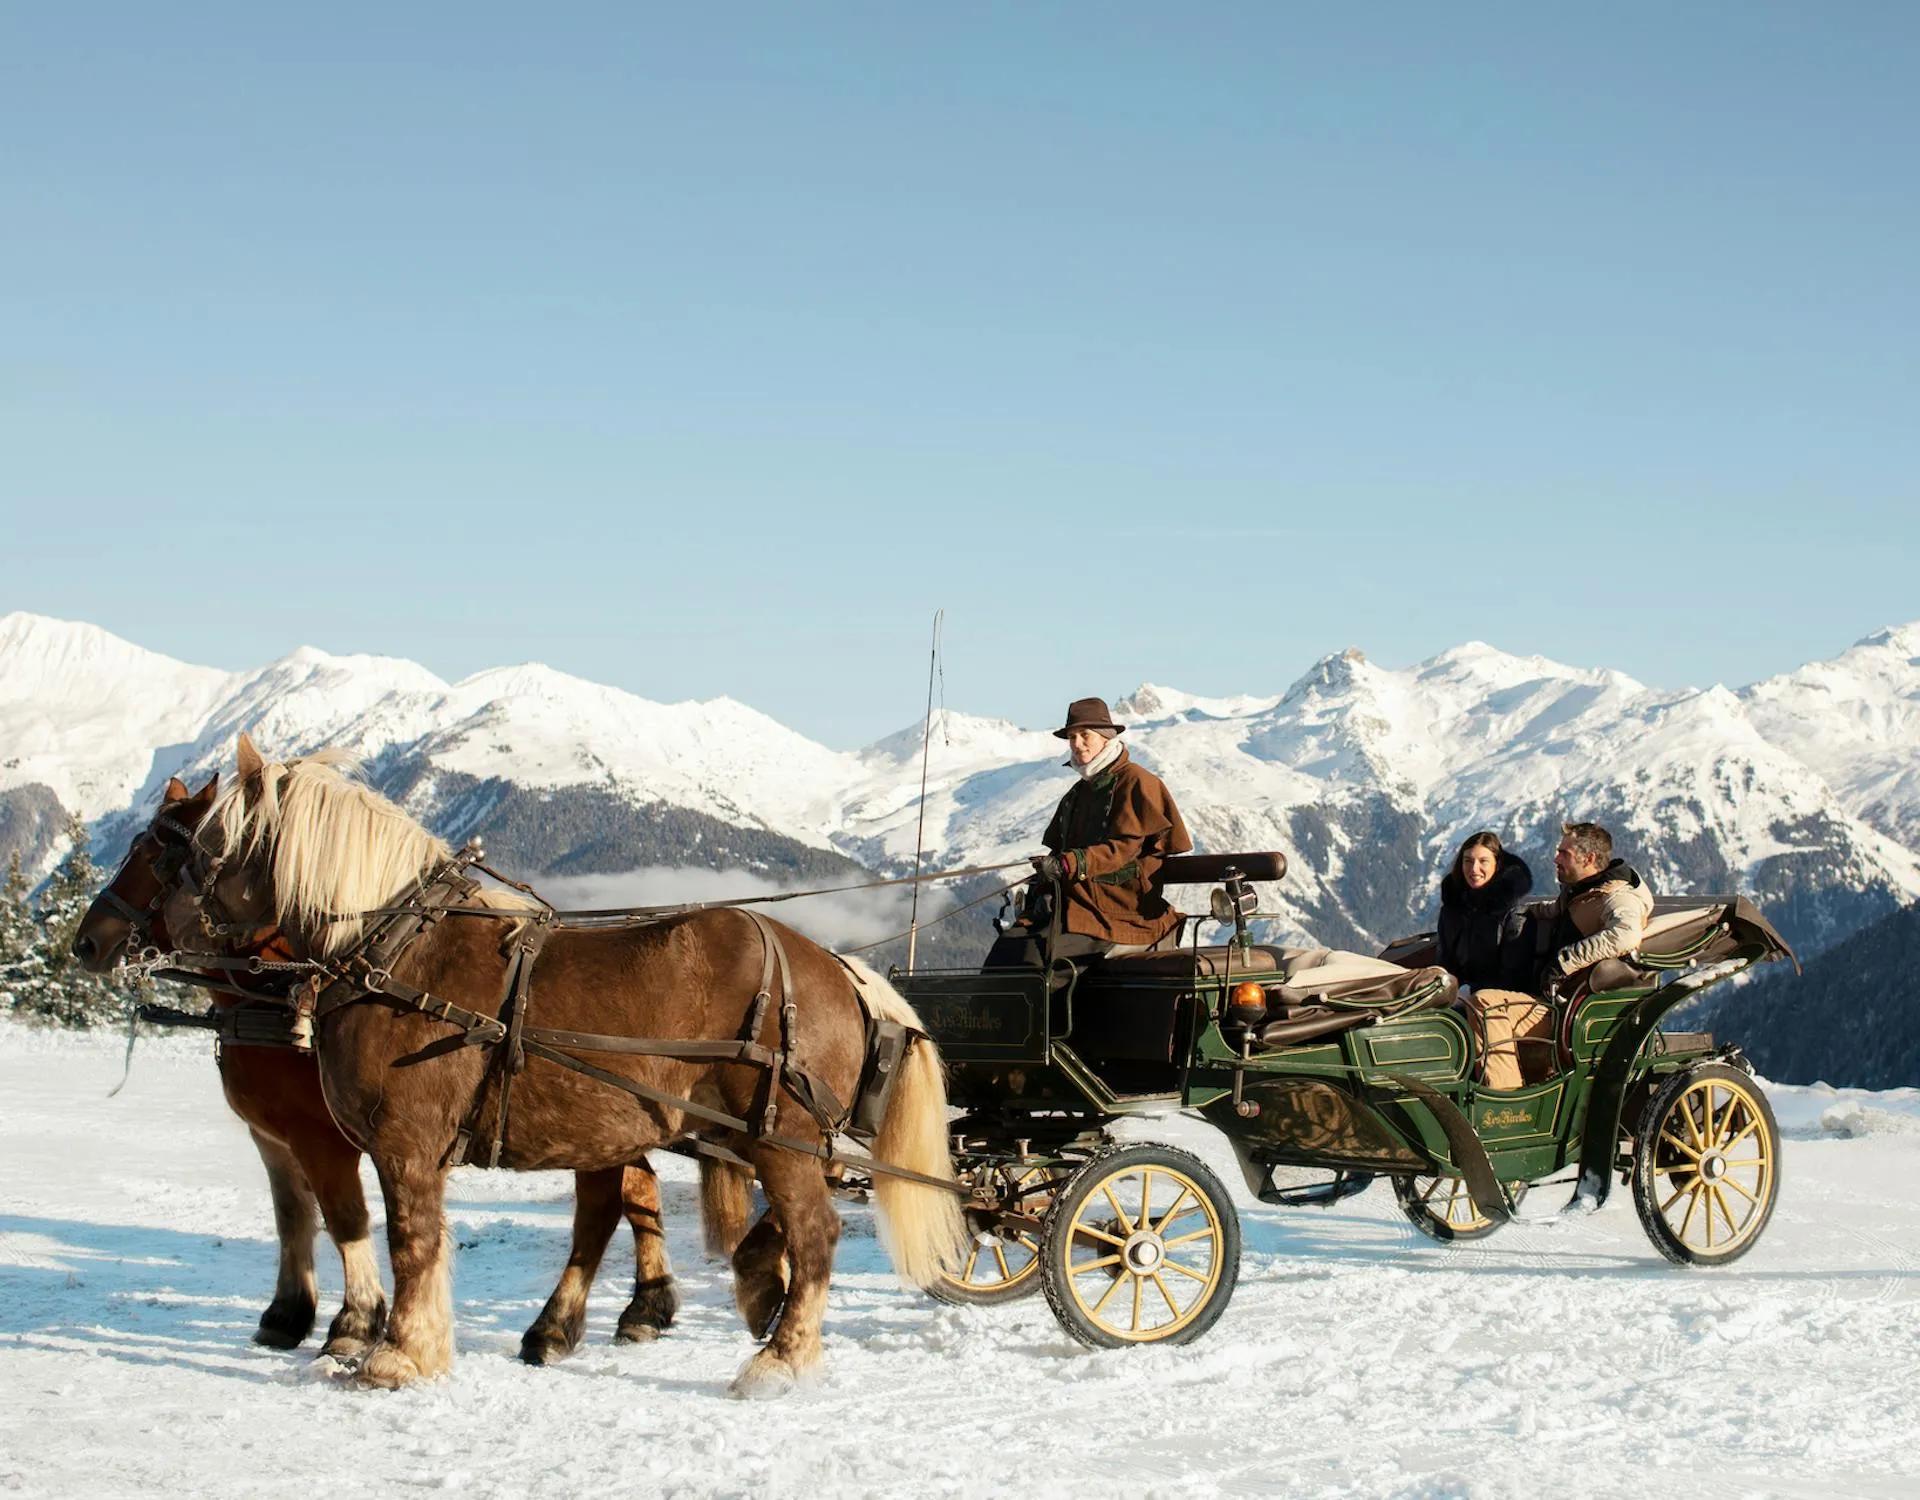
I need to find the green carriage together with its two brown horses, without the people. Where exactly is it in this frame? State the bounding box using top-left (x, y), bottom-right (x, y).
top-left (79, 738), bottom-right (1791, 1392)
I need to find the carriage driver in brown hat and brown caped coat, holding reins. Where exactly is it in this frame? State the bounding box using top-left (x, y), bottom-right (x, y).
top-left (987, 697), bottom-right (1194, 968)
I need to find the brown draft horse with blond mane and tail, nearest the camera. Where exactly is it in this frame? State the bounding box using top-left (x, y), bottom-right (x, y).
top-left (163, 736), bottom-right (964, 1394)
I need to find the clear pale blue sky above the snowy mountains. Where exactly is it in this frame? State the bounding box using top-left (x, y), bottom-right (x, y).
top-left (0, 4), bottom-right (1920, 745)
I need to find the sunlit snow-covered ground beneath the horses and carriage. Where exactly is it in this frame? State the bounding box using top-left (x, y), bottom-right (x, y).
top-left (0, 1024), bottom-right (1920, 1500)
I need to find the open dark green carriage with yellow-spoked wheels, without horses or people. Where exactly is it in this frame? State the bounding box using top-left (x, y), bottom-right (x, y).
top-left (893, 855), bottom-right (1791, 1346)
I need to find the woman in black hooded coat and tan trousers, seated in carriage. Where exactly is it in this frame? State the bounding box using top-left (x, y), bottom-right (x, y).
top-left (1440, 834), bottom-right (1544, 1089)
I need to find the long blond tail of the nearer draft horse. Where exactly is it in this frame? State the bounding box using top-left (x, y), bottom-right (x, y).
top-left (845, 958), bottom-right (966, 1287)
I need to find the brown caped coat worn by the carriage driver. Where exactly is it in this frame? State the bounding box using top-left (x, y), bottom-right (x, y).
top-left (1043, 751), bottom-right (1194, 943)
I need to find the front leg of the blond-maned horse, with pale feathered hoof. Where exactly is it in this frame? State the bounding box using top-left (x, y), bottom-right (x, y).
top-left (357, 1158), bottom-right (453, 1391)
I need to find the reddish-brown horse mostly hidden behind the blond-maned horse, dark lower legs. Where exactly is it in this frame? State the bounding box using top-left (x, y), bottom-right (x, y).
top-left (73, 776), bottom-right (706, 1364)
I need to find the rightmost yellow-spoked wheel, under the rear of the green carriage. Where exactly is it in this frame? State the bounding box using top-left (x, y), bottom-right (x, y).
top-left (1634, 1062), bottom-right (1780, 1266)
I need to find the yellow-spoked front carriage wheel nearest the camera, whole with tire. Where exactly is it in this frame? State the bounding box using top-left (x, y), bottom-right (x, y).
top-left (1041, 1147), bottom-right (1240, 1348)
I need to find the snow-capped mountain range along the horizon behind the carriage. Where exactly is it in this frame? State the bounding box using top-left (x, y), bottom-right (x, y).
top-left (0, 615), bottom-right (1920, 949)
